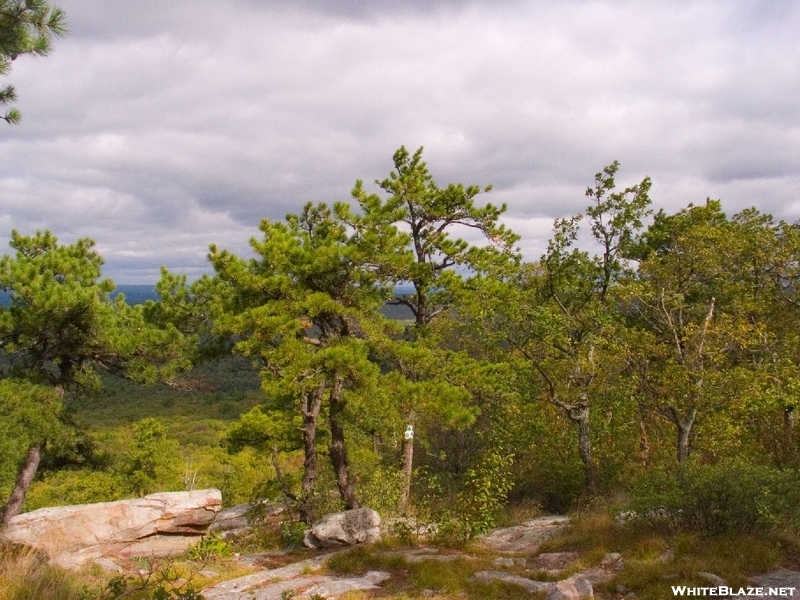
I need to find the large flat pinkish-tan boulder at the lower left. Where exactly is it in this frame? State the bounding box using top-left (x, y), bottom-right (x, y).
top-left (3, 489), bottom-right (222, 570)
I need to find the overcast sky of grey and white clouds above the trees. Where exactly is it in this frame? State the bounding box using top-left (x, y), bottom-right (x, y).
top-left (0, 0), bottom-right (800, 284)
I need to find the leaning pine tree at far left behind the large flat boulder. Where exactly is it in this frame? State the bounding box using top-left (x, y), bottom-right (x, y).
top-left (0, 231), bottom-right (188, 522)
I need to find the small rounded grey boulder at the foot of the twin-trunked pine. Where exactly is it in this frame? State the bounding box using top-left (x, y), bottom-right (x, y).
top-left (303, 508), bottom-right (381, 549)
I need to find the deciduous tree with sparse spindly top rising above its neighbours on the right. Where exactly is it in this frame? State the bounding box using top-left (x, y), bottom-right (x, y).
top-left (465, 162), bottom-right (650, 490)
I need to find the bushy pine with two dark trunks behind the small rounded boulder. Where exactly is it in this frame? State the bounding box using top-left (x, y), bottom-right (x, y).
top-left (210, 203), bottom-right (405, 522)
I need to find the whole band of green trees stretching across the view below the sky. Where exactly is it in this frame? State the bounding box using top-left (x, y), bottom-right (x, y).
top-left (0, 148), bottom-right (800, 535)
